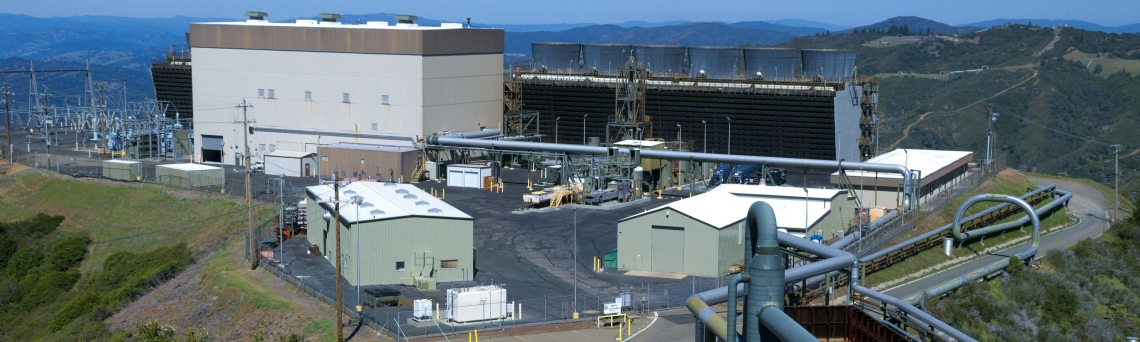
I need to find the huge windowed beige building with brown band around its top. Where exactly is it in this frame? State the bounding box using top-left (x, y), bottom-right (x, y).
top-left (190, 19), bottom-right (503, 164)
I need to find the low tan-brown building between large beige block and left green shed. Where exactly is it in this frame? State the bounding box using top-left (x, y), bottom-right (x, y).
top-left (317, 143), bottom-right (423, 181)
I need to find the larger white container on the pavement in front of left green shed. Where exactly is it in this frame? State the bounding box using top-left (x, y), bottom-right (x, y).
top-left (447, 285), bottom-right (507, 323)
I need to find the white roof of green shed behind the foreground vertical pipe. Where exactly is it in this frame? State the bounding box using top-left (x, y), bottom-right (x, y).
top-left (622, 185), bottom-right (842, 230)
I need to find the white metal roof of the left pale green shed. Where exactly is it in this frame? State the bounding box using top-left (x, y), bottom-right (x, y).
top-left (308, 181), bottom-right (471, 222)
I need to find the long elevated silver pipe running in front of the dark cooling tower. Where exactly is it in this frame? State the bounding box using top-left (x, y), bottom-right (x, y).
top-left (426, 137), bottom-right (914, 209)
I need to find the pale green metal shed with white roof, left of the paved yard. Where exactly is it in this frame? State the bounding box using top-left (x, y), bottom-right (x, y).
top-left (306, 181), bottom-right (474, 290)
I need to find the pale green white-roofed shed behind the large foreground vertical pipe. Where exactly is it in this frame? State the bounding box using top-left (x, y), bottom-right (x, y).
top-left (618, 185), bottom-right (855, 277)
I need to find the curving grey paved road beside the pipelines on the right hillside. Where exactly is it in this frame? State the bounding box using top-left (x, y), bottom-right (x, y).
top-left (886, 177), bottom-right (1108, 299)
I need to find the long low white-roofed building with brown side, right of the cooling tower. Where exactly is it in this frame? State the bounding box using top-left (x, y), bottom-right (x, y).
top-left (831, 148), bottom-right (974, 209)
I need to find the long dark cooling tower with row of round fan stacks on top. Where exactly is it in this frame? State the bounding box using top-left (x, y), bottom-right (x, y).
top-left (505, 43), bottom-right (878, 161)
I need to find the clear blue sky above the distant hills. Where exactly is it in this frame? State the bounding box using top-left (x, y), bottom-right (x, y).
top-left (0, 0), bottom-right (1140, 26)
